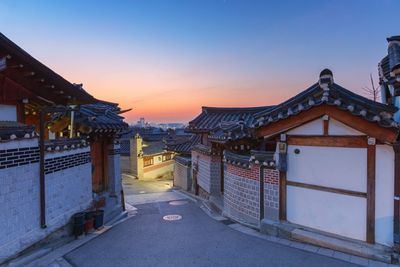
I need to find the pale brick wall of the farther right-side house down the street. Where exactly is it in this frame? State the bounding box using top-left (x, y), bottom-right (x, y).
top-left (192, 151), bottom-right (221, 195)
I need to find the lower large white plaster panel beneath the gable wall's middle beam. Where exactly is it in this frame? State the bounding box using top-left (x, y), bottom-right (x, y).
top-left (287, 186), bottom-right (367, 241)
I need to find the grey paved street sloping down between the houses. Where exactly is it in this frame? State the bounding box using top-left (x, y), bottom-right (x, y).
top-left (61, 179), bottom-right (356, 267)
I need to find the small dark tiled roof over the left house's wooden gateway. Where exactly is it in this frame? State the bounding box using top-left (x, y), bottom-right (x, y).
top-left (76, 102), bottom-right (128, 133)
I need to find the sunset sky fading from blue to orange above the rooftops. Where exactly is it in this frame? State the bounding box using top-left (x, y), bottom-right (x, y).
top-left (0, 0), bottom-right (400, 123)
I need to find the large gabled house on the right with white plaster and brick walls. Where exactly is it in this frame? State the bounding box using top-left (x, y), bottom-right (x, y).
top-left (186, 37), bottom-right (400, 262)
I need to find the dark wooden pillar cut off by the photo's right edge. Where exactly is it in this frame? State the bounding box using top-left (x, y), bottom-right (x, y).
top-left (393, 143), bottom-right (400, 244)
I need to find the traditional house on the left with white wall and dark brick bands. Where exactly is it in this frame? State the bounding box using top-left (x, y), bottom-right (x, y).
top-left (0, 34), bottom-right (126, 263)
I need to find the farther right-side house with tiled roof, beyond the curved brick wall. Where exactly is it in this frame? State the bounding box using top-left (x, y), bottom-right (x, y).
top-left (186, 107), bottom-right (270, 198)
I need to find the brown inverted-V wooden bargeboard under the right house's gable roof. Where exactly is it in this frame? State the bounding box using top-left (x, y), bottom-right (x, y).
top-left (256, 105), bottom-right (398, 146)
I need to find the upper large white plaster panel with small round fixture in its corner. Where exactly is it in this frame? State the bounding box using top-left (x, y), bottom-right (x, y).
top-left (287, 145), bottom-right (367, 192)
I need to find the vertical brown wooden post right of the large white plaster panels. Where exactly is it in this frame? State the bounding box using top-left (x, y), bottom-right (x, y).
top-left (367, 145), bottom-right (376, 244)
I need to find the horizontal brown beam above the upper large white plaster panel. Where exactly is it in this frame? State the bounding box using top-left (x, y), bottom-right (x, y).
top-left (288, 135), bottom-right (368, 148)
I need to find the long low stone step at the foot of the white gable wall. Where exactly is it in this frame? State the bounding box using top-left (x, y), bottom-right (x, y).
top-left (291, 228), bottom-right (394, 263)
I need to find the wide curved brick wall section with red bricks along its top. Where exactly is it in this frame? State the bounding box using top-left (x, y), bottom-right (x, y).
top-left (224, 163), bottom-right (260, 225)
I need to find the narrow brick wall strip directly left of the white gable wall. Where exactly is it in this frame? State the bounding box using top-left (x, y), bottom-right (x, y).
top-left (264, 169), bottom-right (279, 220)
